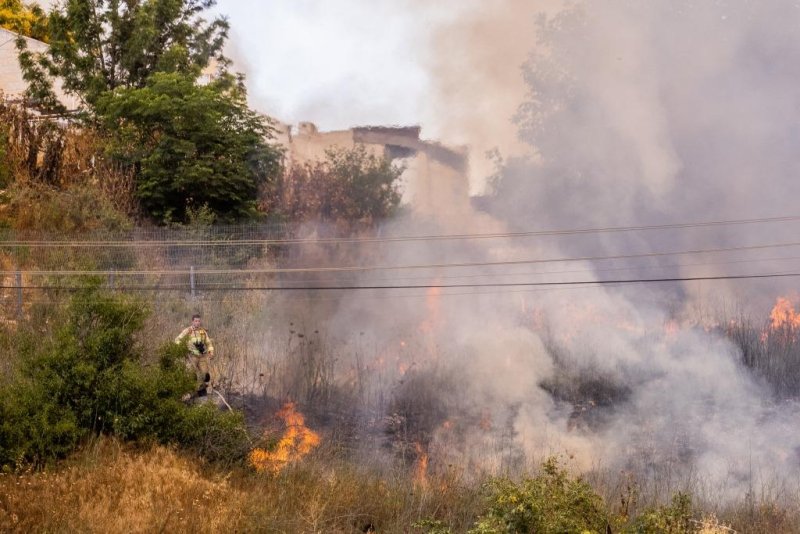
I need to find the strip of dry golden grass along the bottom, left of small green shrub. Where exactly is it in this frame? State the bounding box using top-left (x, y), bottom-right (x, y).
top-left (0, 439), bottom-right (480, 533)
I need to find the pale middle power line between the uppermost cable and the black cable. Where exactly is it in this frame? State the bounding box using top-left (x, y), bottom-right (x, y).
top-left (0, 241), bottom-right (800, 276)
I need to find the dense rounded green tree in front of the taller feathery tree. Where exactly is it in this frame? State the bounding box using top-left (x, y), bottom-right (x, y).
top-left (97, 73), bottom-right (281, 222)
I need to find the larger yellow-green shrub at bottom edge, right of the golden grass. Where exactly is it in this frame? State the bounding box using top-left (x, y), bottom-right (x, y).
top-left (470, 458), bottom-right (609, 534)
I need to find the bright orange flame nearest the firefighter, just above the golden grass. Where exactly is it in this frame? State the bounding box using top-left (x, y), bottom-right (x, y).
top-left (249, 402), bottom-right (320, 473)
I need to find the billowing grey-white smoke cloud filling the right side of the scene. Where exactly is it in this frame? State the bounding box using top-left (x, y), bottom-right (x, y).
top-left (230, 0), bottom-right (800, 506)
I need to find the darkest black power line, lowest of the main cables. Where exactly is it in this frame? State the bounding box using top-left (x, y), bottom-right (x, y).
top-left (0, 272), bottom-right (800, 291)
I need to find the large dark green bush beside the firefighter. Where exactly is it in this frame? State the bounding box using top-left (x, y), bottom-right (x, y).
top-left (0, 289), bottom-right (248, 468)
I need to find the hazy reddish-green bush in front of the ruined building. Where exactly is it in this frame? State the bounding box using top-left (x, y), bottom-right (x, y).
top-left (263, 145), bottom-right (403, 227)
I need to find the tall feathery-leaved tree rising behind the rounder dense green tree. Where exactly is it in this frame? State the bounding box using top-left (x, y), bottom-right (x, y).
top-left (17, 0), bottom-right (228, 112)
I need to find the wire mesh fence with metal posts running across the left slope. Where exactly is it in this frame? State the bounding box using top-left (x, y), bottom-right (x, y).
top-left (0, 224), bottom-right (392, 316)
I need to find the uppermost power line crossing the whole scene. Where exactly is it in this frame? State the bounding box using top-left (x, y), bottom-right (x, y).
top-left (2, 215), bottom-right (800, 248)
